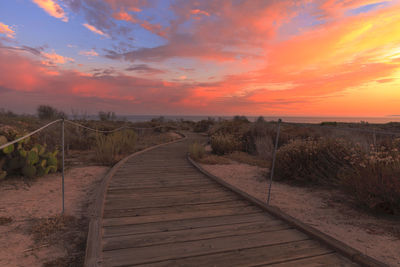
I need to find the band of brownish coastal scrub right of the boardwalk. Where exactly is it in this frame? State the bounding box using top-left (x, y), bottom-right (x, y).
top-left (191, 116), bottom-right (400, 217)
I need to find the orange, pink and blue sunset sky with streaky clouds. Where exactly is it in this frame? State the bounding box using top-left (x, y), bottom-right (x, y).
top-left (0, 0), bottom-right (400, 117)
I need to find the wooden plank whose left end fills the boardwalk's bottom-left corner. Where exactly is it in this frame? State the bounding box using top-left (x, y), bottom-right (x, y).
top-left (103, 229), bottom-right (308, 266)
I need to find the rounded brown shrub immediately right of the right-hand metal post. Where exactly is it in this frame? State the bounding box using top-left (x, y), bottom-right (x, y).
top-left (275, 138), bottom-right (354, 184)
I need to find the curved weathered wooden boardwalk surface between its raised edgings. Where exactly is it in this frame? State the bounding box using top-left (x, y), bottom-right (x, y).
top-left (100, 135), bottom-right (360, 266)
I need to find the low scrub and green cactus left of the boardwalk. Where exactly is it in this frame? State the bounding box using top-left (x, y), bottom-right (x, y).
top-left (0, 105), bottom-right (181, 180)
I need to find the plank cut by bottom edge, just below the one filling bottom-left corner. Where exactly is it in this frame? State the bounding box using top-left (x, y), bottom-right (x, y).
top-left (142, 240), bottom-right (331, 267)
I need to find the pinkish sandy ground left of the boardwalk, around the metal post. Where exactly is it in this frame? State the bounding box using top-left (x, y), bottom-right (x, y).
top-left (0, 166), bottom-right (108, 267)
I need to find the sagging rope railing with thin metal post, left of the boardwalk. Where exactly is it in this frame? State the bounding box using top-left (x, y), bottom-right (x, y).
top-left (0, 119), bottom-right (162, 214)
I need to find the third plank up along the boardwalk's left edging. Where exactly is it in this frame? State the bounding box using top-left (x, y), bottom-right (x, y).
top-left (103, 212), bottom-right (274, 237)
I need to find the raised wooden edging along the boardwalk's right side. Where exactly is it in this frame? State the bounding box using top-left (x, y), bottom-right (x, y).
top-left (187, 153), bottom-right (388, 267)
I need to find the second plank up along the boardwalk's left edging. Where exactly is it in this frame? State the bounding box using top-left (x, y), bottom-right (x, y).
top-left (103, 220), bottom-right (290, 251)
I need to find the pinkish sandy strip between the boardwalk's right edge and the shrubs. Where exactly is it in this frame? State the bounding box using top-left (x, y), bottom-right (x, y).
top-left (202, 163), bottom-right (400, 266)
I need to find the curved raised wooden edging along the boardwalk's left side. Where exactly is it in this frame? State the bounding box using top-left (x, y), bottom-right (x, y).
top-left (84, 132), bottom-right (187, 267)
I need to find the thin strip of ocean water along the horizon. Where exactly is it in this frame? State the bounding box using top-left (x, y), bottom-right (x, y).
top-left (123, 115), bottom-right (400, 123)
